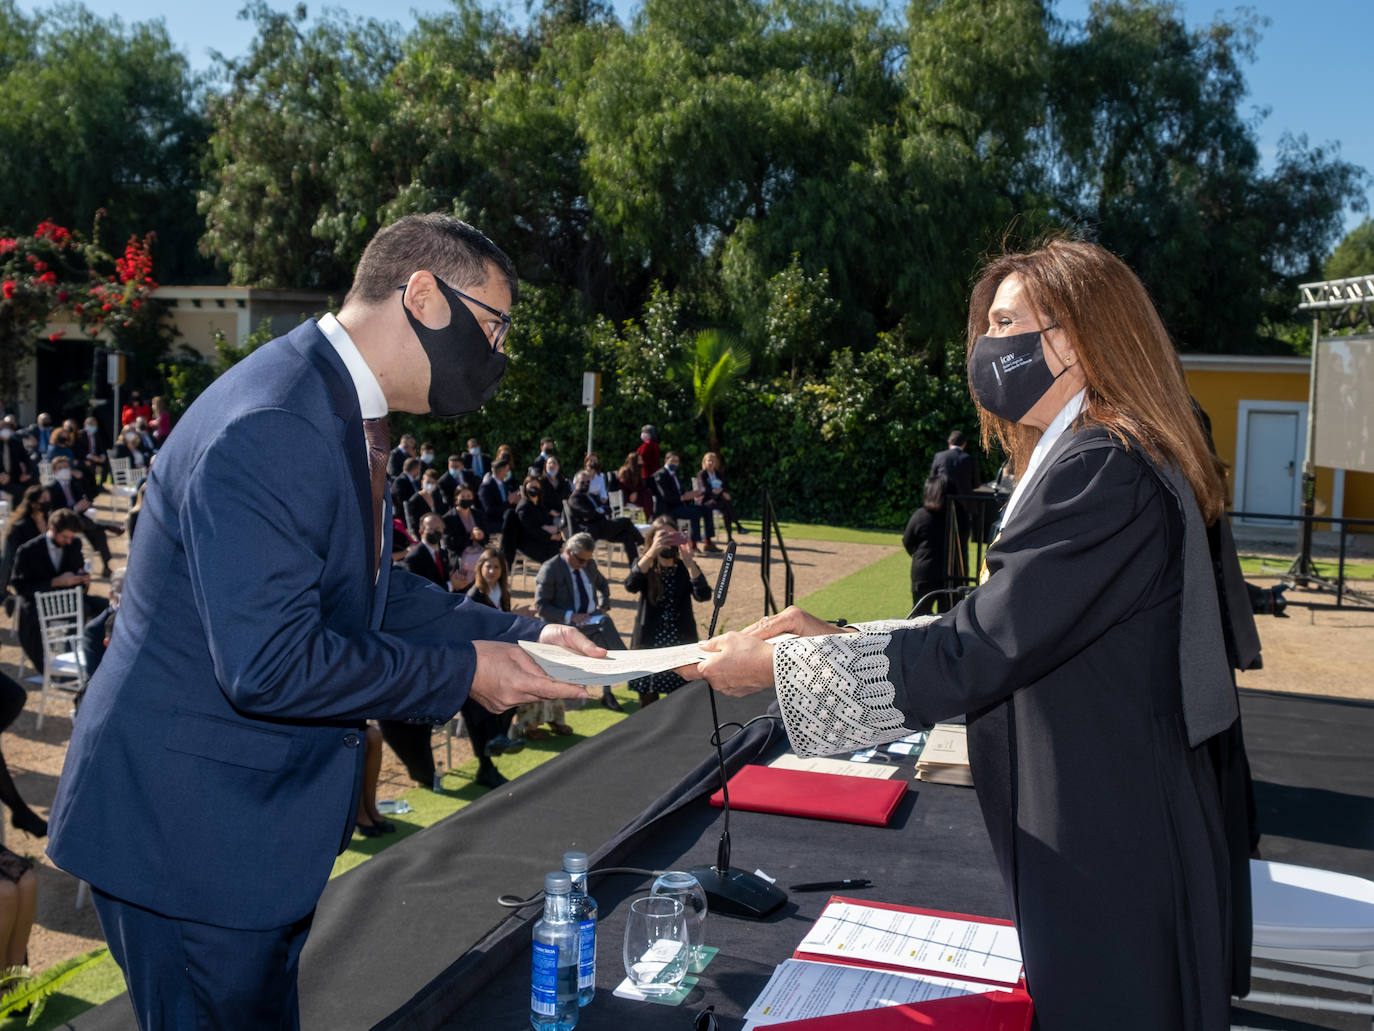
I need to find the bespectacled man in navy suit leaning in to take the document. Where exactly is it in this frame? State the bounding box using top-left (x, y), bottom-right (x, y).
top-left (48, 214), bottom-right (600, 1031)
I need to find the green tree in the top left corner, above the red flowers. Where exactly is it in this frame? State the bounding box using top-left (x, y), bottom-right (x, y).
top-left (0, 0), bottom-right (207, 280)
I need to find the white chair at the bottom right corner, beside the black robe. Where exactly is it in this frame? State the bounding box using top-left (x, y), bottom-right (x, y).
top-left (1245, 859), bottom-right (1374, 1017)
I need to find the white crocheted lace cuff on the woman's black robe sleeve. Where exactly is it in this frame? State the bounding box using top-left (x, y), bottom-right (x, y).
top-left (774, 620), bottom-right (912, 756)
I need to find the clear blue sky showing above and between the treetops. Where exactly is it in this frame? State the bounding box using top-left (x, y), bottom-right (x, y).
top-left (21, 0), bottom-right (1374, 240)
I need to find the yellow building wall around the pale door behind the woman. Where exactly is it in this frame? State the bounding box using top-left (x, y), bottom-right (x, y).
top-left (1186, 368), bottom-right (1374, 529)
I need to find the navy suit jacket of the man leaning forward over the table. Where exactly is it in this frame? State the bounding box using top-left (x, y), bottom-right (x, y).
top-left (48, 322), bottom-right (541, 929)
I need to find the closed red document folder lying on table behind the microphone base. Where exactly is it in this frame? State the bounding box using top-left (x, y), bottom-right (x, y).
top-left (710, 766), bottom-right (907, 828)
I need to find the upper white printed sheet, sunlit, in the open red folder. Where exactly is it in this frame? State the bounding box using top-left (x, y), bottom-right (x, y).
top-left (797, 902), bottom-right (1021, 986)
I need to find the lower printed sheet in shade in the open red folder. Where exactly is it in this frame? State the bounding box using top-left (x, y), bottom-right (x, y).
top-left (741, 960), bottom-right (1010, 1031)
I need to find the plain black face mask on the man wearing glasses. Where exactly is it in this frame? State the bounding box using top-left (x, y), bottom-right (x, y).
top-left (401, 276), bottom-right (506, 419)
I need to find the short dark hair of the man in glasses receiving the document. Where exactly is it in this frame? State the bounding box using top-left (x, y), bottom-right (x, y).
top-left (344, 212), bottom-right (518, 304)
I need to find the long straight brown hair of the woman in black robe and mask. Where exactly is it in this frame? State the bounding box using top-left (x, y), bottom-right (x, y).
top-left (967, 239), bottom-right (1226, 525)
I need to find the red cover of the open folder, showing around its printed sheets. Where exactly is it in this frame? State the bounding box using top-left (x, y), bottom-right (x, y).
top-left (758, 896), bottom-right (1035, 1031)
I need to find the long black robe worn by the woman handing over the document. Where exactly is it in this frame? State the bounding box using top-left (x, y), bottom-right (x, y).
top-left (888, 429), bottom-right (1249, 1031)
